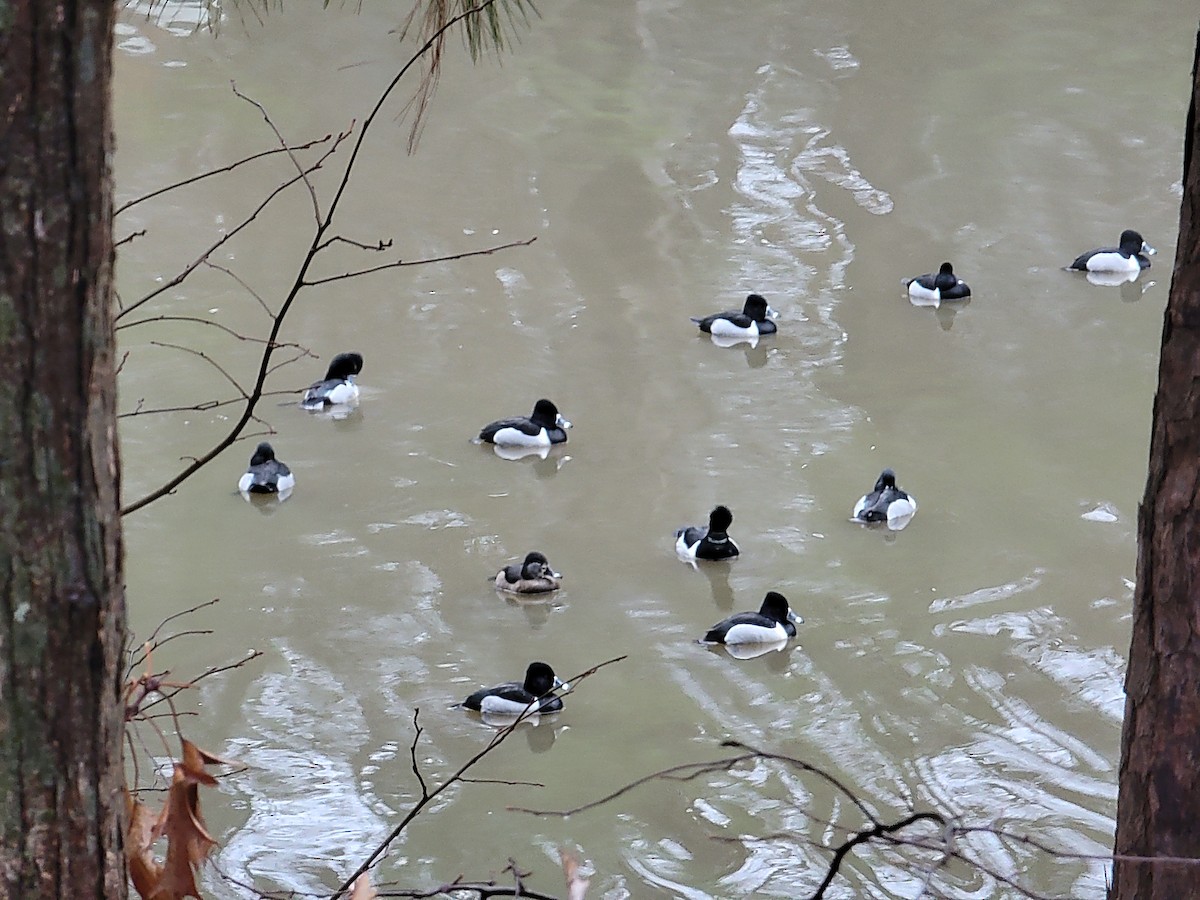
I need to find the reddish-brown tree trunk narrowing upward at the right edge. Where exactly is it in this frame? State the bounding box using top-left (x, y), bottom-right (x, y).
top-left (1109, 21), bottom-right (1200, 900)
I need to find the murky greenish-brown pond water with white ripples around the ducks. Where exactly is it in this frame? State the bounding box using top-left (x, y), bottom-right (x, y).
top-left (116, 0), bottom-right (1195, 900)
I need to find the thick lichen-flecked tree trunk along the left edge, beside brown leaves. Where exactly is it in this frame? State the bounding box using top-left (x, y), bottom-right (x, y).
top-left (0, 0), bottom-right (127, 900)
